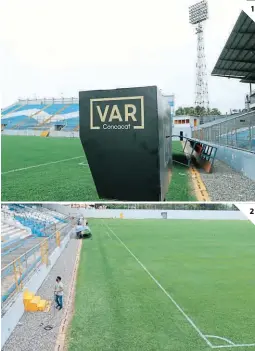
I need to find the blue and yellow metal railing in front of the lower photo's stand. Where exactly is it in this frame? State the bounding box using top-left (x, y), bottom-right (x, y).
top-left (1, 219), bottom-right (74, 307)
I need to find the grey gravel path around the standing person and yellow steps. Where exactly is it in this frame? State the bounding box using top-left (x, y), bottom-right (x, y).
top-left (2, 239), bottom-right (78, 351)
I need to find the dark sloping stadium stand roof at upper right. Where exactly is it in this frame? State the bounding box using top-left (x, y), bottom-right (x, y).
top-left (212, 11), bottom-right (255, 83)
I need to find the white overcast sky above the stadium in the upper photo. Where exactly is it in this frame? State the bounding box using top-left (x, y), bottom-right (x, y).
top-left (0, 0), bottom-right (249, 113)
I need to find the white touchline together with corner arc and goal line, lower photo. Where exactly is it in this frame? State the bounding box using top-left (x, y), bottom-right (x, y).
top-left (103, 220), bottom-right (255, 349)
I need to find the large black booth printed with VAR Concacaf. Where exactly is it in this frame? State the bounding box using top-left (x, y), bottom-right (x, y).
top-left (79, 86), bottom-right (172, 201)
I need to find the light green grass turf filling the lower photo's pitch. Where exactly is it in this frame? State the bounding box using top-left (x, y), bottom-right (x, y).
top-left (68, 219), bottom-right (255, 351)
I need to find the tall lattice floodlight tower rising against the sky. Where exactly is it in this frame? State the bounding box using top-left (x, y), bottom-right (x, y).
top-left (189, 0), bottom-right (209, 109)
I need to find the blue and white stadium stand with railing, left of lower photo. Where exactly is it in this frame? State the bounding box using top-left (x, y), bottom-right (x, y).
top-left (1, 204), bottom-right (70, 303)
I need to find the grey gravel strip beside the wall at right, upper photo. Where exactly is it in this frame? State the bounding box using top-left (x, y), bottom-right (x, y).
top-left (200, 160), bottom-right (255, 202)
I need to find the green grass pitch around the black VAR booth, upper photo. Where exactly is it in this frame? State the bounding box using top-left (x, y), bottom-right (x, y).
top-left (2, 135), bottom-right (195, 202)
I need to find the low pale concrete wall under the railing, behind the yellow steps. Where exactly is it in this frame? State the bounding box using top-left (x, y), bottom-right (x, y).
top-left (1, 232), bottom-right (71, 348)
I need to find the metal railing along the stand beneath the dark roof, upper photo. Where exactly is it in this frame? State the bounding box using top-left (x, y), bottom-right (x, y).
top-left (192, 111), bottom-right (255, 153)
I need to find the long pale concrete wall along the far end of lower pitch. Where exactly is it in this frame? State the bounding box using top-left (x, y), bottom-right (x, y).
top-left (43, 204), bottom-right (247, 220)
